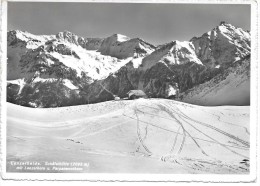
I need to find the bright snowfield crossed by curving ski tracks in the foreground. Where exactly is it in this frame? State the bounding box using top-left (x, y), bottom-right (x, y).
top-left (7, 99), bottom-right (250, 174)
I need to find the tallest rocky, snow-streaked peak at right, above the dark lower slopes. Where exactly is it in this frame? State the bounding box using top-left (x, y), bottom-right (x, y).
top-left (191, 22), bottom-right (251, 68)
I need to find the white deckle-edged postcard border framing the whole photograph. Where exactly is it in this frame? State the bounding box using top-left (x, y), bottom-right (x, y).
top-left (0, 0), bottom-right (259, 183)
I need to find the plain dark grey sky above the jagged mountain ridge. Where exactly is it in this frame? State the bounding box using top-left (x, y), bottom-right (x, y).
top-left (8, 2), bottom-right (250, 45)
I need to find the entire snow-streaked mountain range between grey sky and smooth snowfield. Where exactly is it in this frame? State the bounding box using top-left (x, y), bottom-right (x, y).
top-left (7, 22), bottom-right (251, 107)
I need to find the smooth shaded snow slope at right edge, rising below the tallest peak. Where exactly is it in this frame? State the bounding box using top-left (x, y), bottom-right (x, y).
top-left (179, 57), bottom-right (250, 105)
